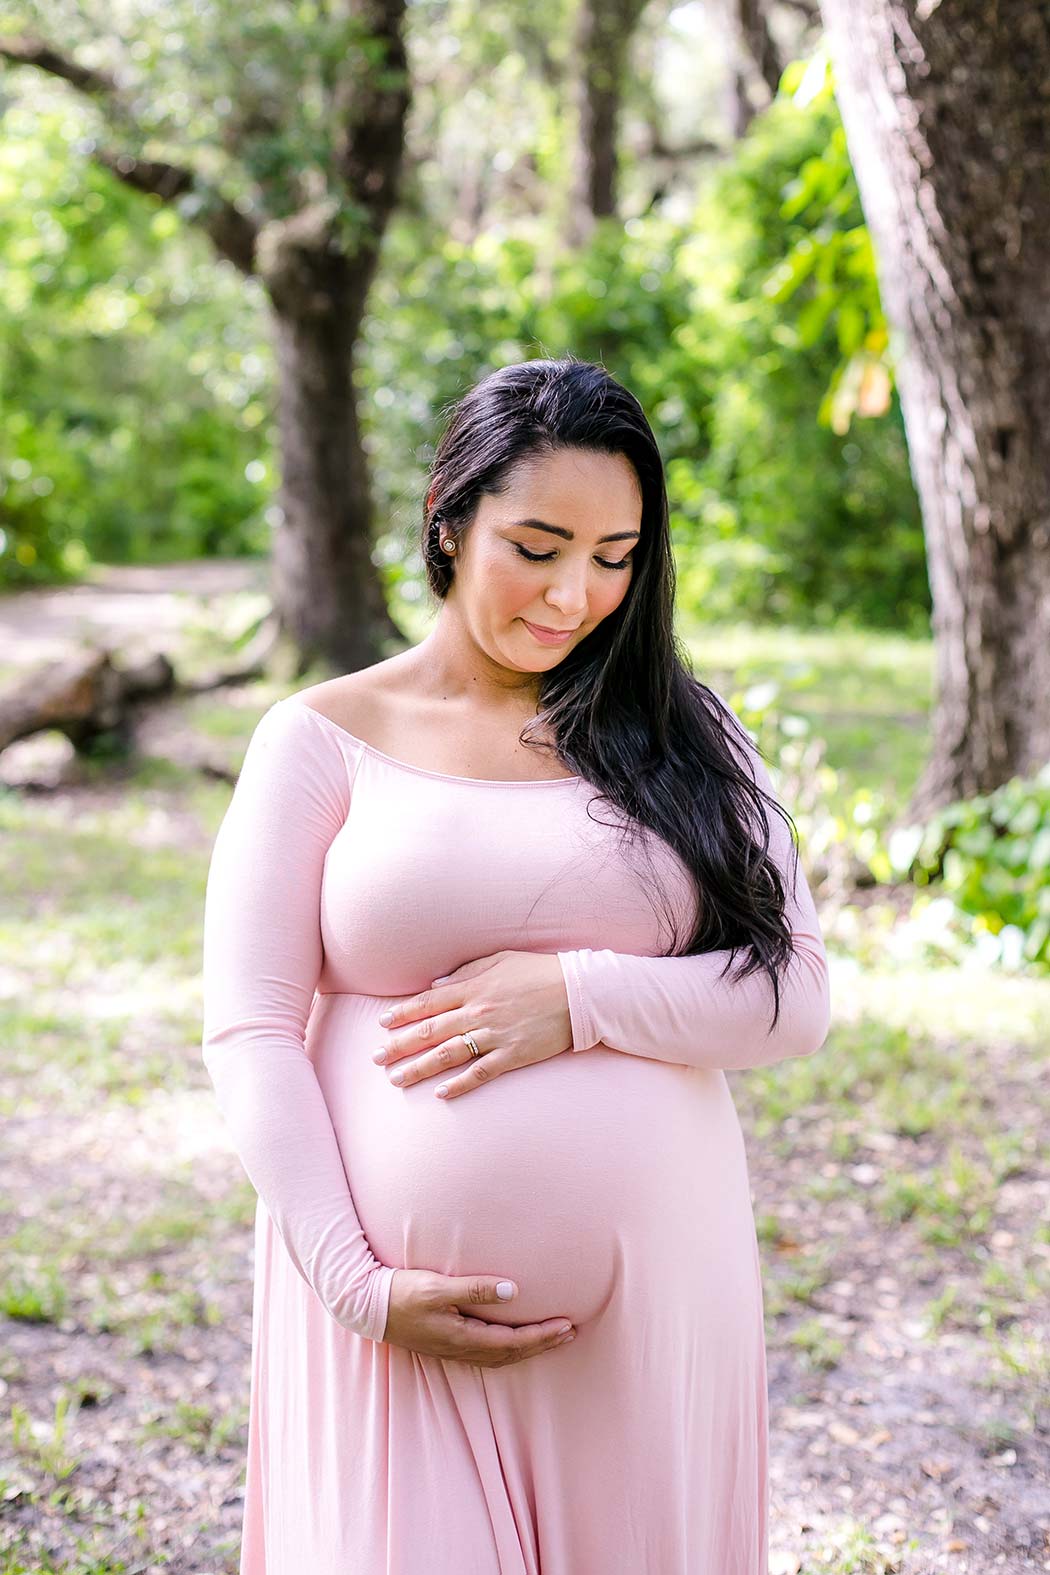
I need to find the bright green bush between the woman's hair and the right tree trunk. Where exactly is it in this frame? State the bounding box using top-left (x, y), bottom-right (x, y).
top-left (669, 57), bottom-right (930, 635)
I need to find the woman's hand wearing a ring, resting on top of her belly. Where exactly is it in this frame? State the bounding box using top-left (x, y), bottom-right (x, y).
top-left (373, 951), bottom-right (573, 1099)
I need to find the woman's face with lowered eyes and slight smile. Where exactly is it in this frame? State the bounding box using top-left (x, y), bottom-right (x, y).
top-left (450, 449), bottom-right (642, 673)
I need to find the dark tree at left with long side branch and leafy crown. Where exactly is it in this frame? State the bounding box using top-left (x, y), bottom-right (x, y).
top-left (0, 0), bottom-right (409, 671)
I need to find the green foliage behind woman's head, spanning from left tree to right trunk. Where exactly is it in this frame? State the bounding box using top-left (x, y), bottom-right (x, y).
top-left (360, 49), bottom-right (930, 635)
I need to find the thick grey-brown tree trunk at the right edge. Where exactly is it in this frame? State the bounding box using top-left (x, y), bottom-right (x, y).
top-left (823, 0), bottom-right (1050, 819)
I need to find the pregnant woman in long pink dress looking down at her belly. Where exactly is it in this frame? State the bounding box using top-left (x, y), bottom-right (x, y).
top-left (203, 358), bottom-right (830, 1575)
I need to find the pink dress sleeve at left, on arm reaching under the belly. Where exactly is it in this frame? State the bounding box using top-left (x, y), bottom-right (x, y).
top-left (201, 702), bottom-right (395, 1340)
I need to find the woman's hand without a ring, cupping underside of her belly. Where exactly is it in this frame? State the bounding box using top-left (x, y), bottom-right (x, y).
top-left (383, 1269), bottom-right (576, 1367)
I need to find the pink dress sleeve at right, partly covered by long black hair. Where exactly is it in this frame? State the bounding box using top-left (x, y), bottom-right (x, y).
top-left (557, 718), bottom-right (831, 1071)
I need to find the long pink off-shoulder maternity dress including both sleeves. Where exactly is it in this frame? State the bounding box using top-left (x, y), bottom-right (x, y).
top-left (203, 695), bottom-right (828, 1575)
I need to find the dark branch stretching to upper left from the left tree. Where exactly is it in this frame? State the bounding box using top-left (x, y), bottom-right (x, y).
top-left (0, 33), bottom-right (258, 274)
